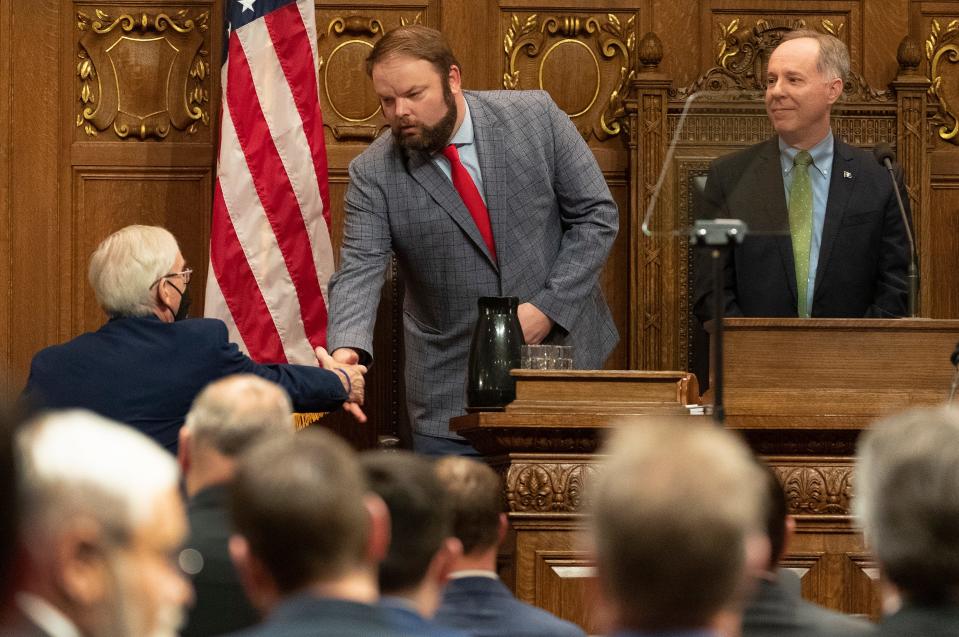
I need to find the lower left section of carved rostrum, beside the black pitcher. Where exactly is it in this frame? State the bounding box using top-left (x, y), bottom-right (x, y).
top-left (450, 370), bottom-right (701, 633)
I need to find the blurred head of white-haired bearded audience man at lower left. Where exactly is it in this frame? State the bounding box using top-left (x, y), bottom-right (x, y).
top-left (17, 411), bottom-right (191, 637)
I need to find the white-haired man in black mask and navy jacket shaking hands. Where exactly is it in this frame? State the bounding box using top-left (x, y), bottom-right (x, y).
top-left (24, 225), bottom-right (366, 453)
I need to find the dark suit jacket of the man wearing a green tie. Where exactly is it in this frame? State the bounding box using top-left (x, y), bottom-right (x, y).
top-left (694, 137), bottom-right (909, 322)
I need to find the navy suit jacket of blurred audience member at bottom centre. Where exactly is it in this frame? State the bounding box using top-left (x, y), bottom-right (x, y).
top-left (433, 577), bottom-right (586, 637)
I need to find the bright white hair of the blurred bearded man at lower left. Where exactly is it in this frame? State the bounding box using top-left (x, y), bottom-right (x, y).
top-left (17, 410), bottom-right (179, 539)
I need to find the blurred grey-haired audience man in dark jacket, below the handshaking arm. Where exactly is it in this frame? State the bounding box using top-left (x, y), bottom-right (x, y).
top-left (179, 374), bottom-right (294, 637)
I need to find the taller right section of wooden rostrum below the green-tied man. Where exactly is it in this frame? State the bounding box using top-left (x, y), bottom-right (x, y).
top-left (724, 318), bottom-right (959, 618)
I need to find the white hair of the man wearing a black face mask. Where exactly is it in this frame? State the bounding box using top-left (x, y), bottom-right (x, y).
top-left (89, 225), bottom-right (180, 316)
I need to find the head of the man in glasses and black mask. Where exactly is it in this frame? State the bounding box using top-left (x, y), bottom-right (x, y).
top-left (89, 225), bottom-right (190, 321)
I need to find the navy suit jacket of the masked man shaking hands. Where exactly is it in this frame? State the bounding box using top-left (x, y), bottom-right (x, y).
top-left (24, 316), bottom-right (347, 453)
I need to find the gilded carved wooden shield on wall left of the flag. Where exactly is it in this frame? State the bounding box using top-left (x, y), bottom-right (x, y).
top-left (76, 9), bottom-right (211, 140)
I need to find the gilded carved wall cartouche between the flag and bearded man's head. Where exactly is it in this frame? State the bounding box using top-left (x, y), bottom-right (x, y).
top-left (317, 11), bottom-right (422, 142)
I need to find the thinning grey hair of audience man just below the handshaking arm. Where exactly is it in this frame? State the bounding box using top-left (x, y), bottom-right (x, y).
top-left (184, 374), bottom-right (295, 457)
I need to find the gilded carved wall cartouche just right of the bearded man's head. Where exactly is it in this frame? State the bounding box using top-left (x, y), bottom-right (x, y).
top-left (503, 13), bottom-right (636, 141)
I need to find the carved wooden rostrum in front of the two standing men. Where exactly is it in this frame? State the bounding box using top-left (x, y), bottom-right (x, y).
top-left (451, 319), bottom-right (959, 632)
